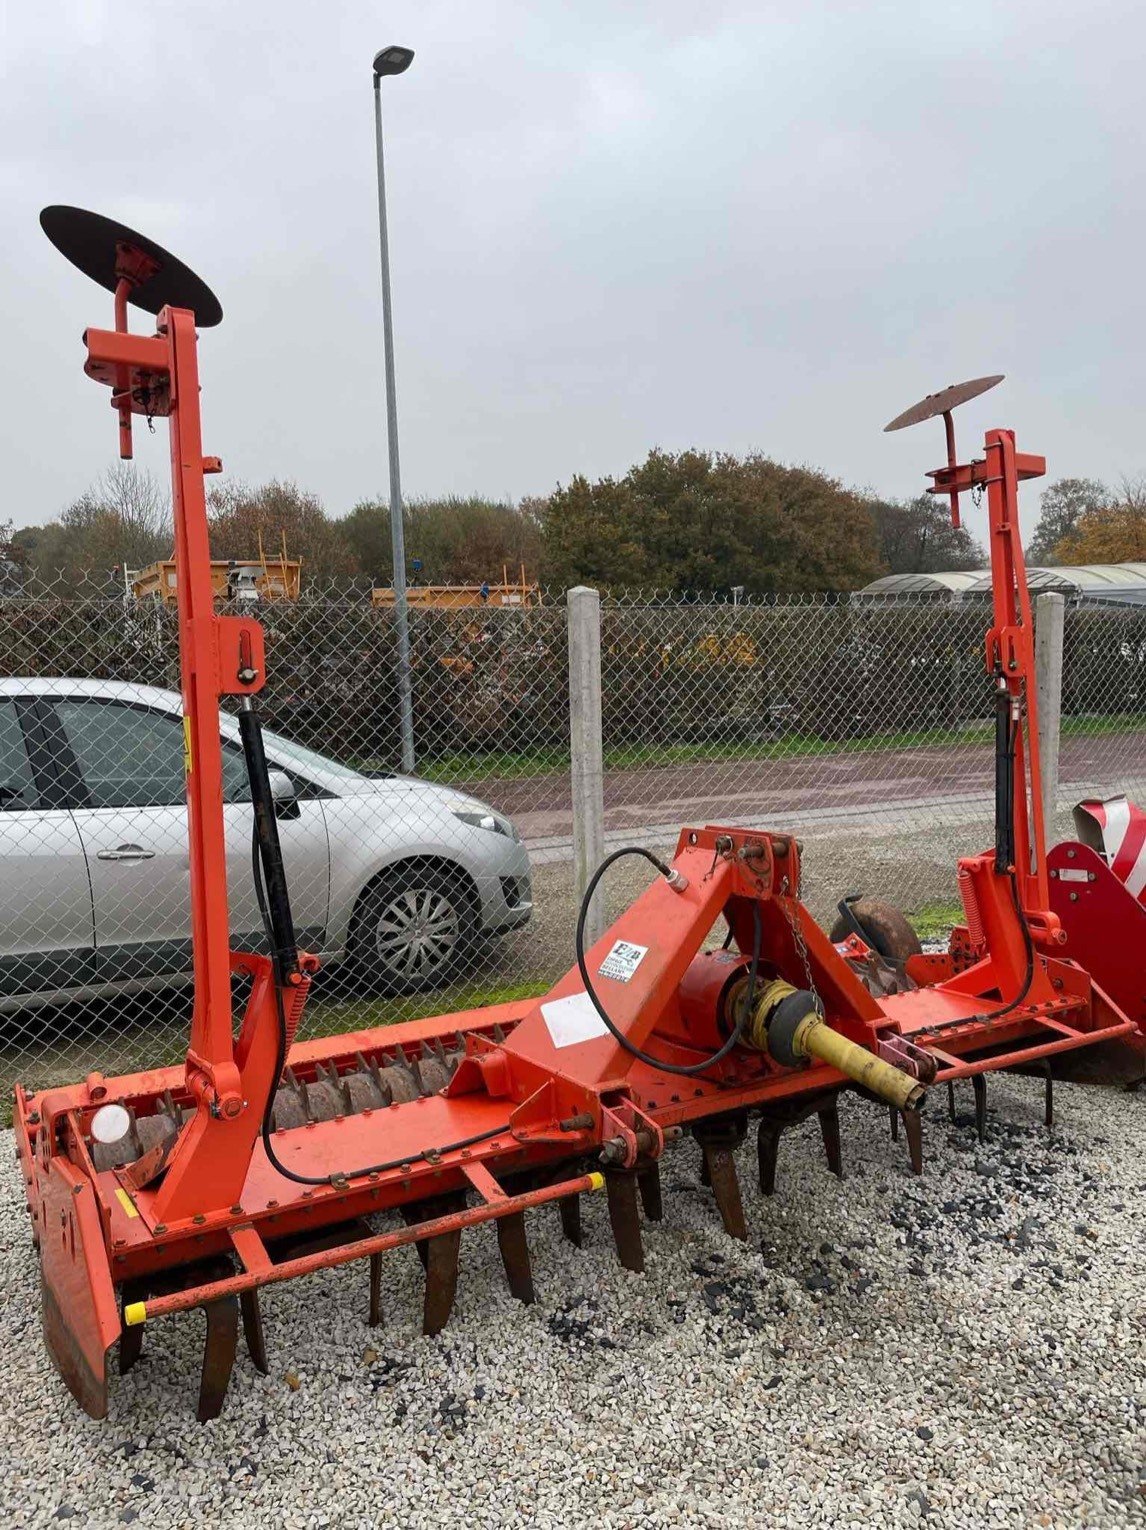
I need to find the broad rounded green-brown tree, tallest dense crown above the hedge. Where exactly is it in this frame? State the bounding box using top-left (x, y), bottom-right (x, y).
top-left (539, 450), bottom-right (880, 594)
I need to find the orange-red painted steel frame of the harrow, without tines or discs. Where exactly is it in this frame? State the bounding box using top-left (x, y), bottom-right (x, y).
top-left (15, 289), bottom-right (1134, 1415)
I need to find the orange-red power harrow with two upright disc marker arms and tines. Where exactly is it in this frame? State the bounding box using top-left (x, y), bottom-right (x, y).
top-left (15, 215), bottom-right (1146, 1418)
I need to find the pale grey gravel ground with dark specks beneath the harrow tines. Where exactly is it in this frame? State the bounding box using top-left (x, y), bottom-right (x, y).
top-left (0, 1079), bottom-right (1146, 1530)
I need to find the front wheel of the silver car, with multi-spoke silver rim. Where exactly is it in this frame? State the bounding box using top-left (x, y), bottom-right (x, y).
top-left (350, 866), bottom-right (477, 993)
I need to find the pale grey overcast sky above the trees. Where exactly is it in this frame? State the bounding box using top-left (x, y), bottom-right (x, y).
top-left (0, 0), bottom-right (1146, 550)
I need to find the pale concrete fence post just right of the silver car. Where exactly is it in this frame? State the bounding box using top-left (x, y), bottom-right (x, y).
top-left (565, 584), bottom-right (604, 949)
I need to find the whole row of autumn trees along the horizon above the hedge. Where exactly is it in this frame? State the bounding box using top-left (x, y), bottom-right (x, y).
top-left (0, 450), bottom-right (1146, 595)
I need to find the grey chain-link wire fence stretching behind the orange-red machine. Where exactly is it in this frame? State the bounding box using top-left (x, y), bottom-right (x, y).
top-left (0, 586), bottom-right (1146, 1089)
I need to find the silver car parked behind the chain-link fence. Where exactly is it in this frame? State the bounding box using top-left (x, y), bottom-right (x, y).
top-left (0, 679), bottom-right (532, 1013)
